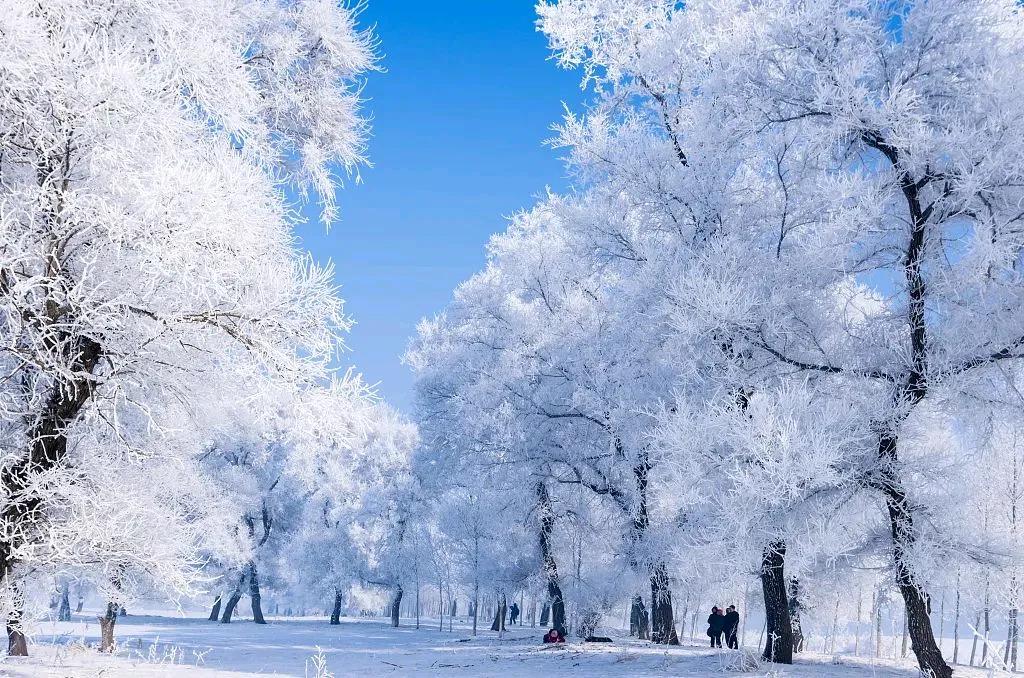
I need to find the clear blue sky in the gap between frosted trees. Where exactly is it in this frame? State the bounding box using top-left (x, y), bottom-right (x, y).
top-left (299, 0), bottom-right (583, 412)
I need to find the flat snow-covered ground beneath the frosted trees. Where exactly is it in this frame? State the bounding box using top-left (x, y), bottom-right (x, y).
top-left (0, 616), bottom-right (1007, 678)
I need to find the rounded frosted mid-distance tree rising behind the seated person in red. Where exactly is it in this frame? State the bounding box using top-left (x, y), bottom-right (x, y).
top-left (407, 199), bottom-right (688, 642)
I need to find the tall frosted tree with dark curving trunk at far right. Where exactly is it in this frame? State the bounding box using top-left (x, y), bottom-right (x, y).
top-left (541, 0), bottom-right (1024, 676)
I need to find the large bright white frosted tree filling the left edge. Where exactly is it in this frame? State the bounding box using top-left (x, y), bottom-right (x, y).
top-left (0, 0), bottom-right (374, 653)
